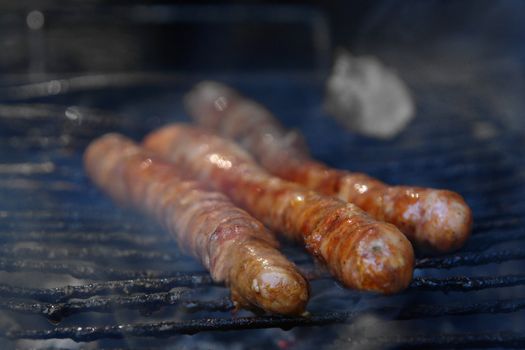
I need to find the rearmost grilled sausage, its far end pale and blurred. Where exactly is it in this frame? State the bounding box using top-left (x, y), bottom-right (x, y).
top-left (185, 82), bottom-right (472, 253)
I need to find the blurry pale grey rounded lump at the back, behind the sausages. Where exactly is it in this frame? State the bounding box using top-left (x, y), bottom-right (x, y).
top-left (325, 51), bottom-right (415, 138)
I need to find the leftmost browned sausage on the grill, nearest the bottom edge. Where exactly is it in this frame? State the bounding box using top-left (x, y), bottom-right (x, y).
top-left (84, 134), bottom-right (309, 315)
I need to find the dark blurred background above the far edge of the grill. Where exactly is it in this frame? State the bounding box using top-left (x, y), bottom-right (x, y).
top-left (0, 0), bottom-right (525, 127)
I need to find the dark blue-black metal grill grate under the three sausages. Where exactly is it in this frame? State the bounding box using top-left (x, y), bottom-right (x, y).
top-left (0, 2), bottom-right (525, 349)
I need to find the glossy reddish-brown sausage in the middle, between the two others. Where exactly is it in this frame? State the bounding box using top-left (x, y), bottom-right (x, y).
top-left (143, 124), bottom-right (414, 293)
